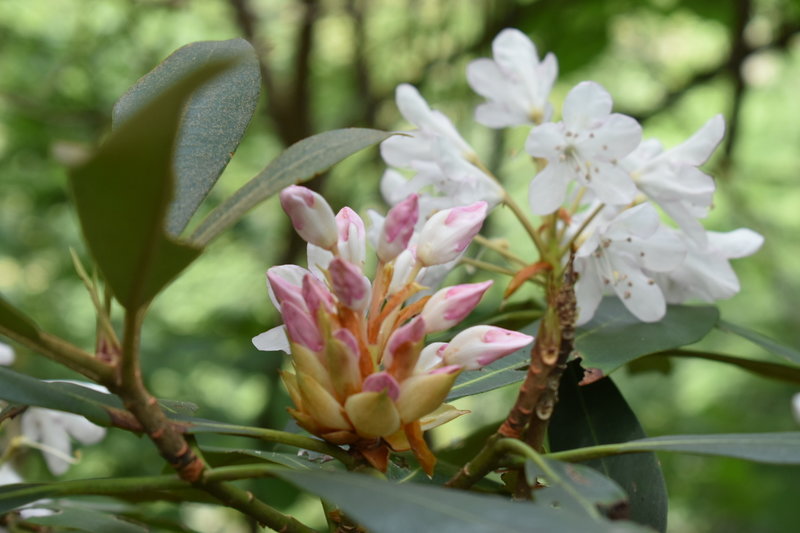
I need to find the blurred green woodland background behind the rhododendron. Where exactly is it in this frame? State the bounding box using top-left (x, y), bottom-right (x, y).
top-left (0, 0), bottom-right (800, 533)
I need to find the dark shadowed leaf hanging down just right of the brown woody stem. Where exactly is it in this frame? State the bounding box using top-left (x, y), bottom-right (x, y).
top-left (548, 362), bottom-right (668, 531)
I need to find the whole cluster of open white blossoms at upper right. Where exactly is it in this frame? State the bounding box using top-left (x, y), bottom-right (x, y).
top-left (381, 29), bottom-right (763, 323)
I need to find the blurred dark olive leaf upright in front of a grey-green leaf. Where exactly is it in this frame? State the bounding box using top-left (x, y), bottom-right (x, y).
top-left (70, 61), bottom-right (236, 310)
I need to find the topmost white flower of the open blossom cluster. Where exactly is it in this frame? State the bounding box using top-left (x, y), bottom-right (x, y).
top-left (467, 29), bottom-right (558, 128)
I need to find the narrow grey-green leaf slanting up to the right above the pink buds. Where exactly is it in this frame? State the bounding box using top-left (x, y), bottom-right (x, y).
top-left (191, 128), bottom-right (393, 246)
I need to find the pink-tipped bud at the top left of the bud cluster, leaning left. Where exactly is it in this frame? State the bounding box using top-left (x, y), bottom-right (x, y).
top-left (280, 185), bottom-right (338, 250)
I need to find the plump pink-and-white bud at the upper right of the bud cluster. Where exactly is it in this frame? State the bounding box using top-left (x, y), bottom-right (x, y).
top-left (417, 202), bottom-right (487, 266)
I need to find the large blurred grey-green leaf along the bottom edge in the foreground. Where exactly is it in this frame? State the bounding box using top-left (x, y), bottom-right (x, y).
top-left (275, 470), bottom-right (642, 533)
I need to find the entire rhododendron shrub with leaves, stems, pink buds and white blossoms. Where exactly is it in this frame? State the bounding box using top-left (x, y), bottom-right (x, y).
top-left (0, 29), bottom-right (800, 533)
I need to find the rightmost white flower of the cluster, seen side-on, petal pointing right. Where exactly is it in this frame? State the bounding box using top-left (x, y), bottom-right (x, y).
top-left (653, 228), bottom-right (764, 303)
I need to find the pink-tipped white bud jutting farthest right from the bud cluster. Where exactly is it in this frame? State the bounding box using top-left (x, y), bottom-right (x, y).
top-left (442, 326), bottom-right (533, 370)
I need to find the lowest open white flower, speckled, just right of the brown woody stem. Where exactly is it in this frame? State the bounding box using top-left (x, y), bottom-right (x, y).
top-left (573, 204), bottom-right (686, 324)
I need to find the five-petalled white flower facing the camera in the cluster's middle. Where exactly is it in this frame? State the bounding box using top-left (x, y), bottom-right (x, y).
top-left (525, 81), bottom-right (642, 215)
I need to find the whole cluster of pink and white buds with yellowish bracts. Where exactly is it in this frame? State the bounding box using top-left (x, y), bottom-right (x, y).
top-left (253, 186), bottom-right (533, 475)
